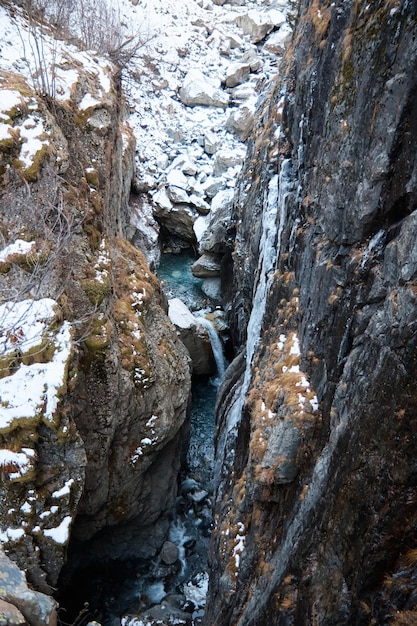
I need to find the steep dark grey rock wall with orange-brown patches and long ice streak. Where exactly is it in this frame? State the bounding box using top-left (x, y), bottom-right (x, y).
top-left (207, 0), bottom-right (417, 626)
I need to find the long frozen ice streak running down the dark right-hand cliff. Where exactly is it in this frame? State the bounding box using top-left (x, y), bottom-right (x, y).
top-left (216, 159), bottom-right (294, 488)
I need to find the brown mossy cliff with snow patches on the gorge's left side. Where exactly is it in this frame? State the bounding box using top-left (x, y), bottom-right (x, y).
top-left (0, 3), bottom-right (190, 612)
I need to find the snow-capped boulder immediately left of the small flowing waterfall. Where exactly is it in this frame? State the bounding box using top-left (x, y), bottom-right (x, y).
top-left (168, 298), bottom-right (215, 376)
